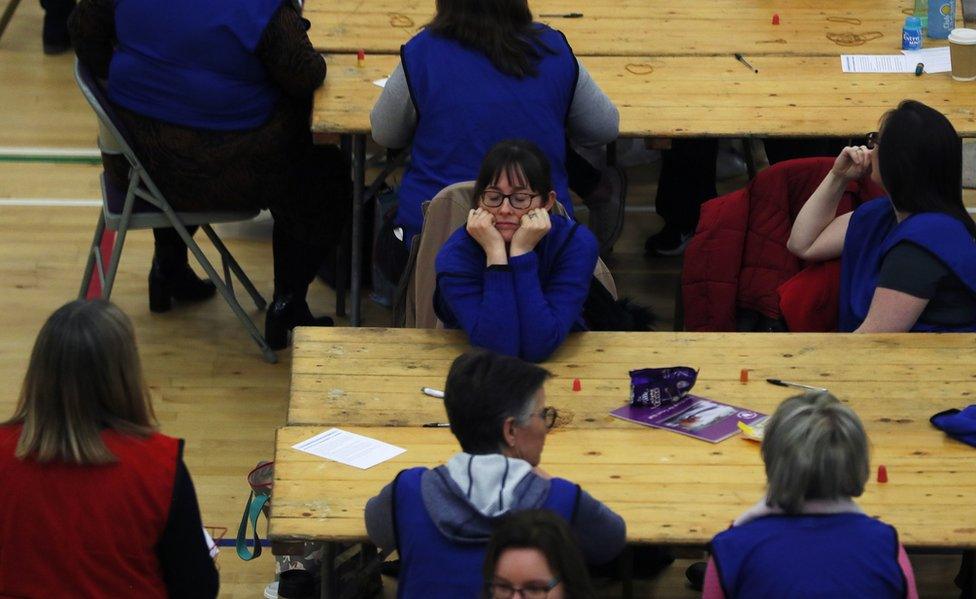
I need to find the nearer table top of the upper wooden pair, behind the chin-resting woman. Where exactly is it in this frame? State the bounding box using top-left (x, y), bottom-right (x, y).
top-left (312, 55), bottom-right (976, 137)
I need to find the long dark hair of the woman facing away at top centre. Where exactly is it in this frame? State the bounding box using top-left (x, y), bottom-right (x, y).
top-left (427, 0), bottom-right (555, 78)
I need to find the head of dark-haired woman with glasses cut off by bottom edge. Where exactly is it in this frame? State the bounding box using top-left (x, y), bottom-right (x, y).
top-left (484, 510), bottom-right (596, 599)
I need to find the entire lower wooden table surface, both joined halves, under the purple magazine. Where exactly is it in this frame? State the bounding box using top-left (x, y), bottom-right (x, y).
top-left (270, 328), bottom-right (976, 548)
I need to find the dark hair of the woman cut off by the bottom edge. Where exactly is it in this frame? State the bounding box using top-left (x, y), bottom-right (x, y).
top-left (482, 510), bottom-right (596, 599)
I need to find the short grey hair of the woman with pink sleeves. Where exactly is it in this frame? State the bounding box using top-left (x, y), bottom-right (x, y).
top-left (762, 392), bottom-right (869, 514)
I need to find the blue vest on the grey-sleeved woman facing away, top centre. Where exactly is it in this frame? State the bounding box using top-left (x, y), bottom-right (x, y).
top-left (397, 24), bottom-right (579, 243)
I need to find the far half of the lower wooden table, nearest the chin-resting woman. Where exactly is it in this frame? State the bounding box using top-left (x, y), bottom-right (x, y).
top-left (288, 328), bottom-right (976, 426)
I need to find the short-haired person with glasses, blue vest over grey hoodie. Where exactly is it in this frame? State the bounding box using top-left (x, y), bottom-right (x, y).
top-left (366, 350), bottom-right (626, 599)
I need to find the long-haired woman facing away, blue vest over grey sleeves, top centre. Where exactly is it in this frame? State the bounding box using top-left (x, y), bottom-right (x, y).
top-left (370, 0), bottom-right (622, 247)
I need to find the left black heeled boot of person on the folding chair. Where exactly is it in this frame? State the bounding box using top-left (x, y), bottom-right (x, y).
top-left (149, 227), bottom-right (217, 312)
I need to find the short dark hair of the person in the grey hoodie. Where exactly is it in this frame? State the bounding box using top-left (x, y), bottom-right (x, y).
top-left (444, 350), bottom-right (550, 455)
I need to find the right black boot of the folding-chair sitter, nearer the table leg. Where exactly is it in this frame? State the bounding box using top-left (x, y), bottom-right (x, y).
top-left (264, 223), bottom-right (334, 350)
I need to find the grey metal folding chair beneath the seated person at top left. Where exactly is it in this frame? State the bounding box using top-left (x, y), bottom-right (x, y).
top-left (75, 61), bottom-right (278, 363)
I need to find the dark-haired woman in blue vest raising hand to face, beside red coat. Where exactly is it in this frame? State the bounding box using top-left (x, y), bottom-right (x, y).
top-left (787, 100), bottom-right (976, 332)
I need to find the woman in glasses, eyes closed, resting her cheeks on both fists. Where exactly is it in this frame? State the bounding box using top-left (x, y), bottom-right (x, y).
top-left (434, 140), bottom-right (598, 362)
